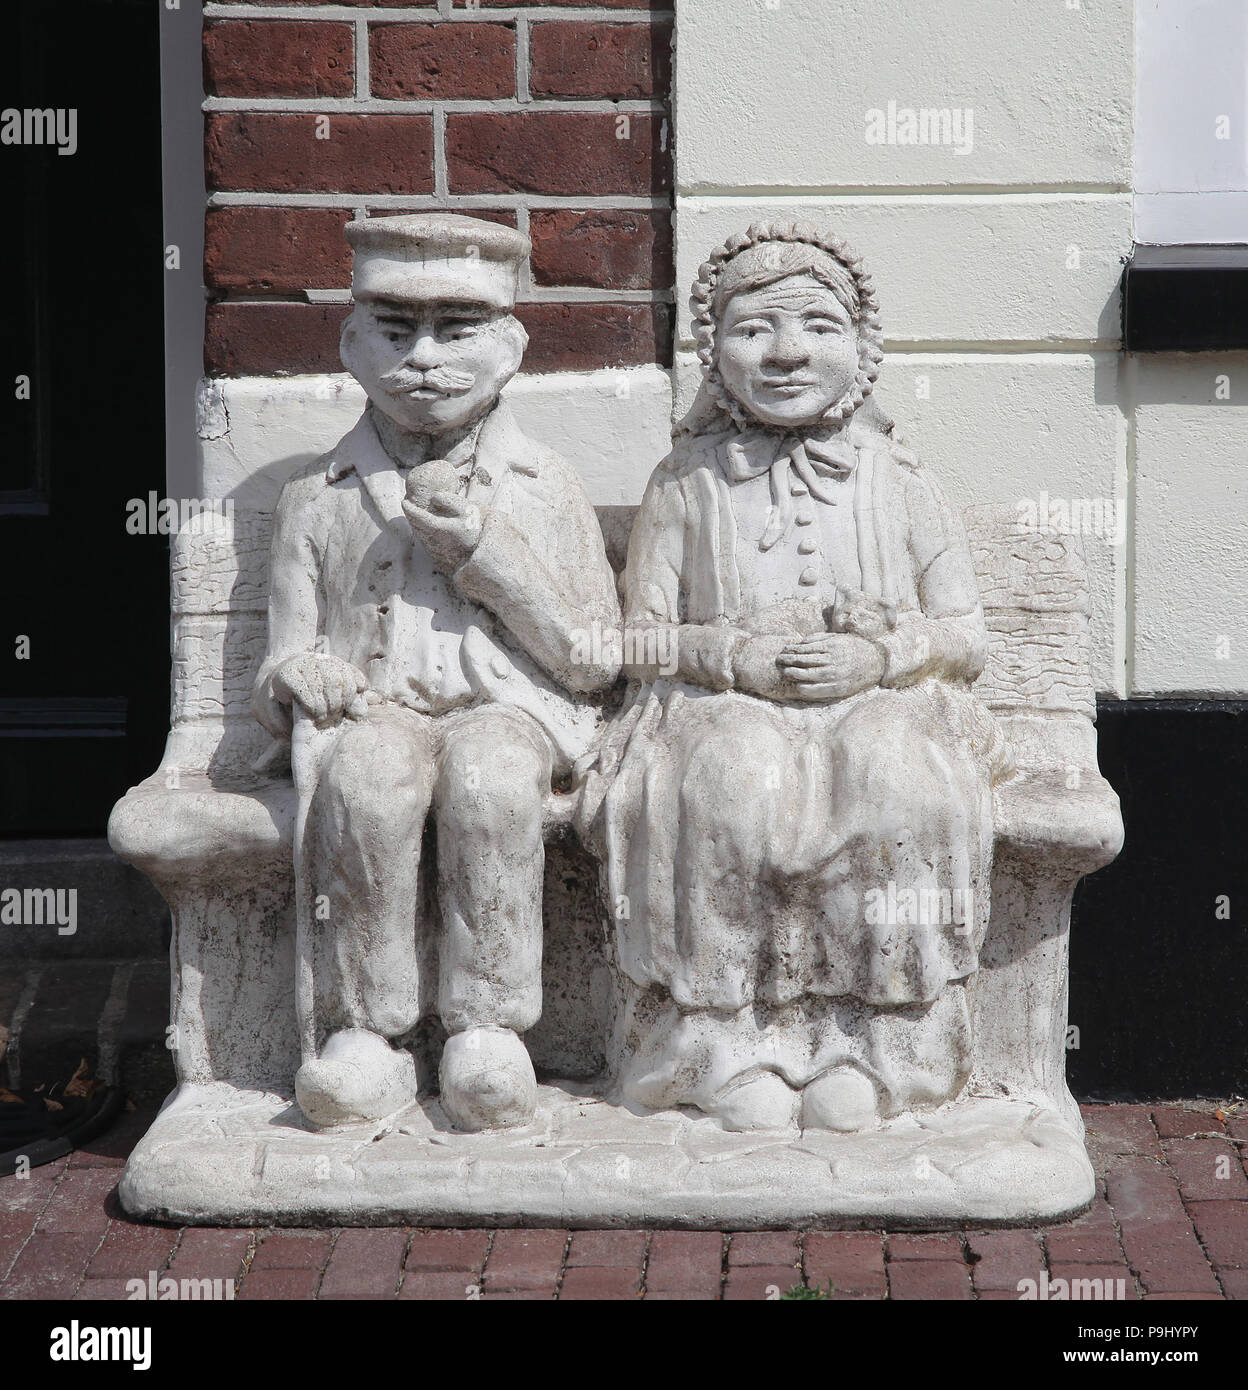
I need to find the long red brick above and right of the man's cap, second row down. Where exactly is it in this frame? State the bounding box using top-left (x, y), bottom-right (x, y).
top-left (441, 111), bottom-right (671, 197)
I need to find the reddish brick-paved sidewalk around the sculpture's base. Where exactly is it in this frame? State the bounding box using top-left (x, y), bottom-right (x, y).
top-left (0, 1102), bottom-right (1248, 1301)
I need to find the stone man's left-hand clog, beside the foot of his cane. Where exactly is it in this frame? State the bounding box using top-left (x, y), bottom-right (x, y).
top-left (295, 1029), bottom-right (416, 1129)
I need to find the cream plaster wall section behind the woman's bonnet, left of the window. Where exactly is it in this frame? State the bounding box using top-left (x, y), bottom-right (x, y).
top-left (675, 0), bottom-right (1134, 696)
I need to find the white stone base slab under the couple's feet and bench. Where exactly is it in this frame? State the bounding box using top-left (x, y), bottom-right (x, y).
top-left (121, 1081), bottom-right (1095, 1230)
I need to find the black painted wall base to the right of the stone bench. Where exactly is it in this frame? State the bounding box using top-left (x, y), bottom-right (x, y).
top-left (1067, 699), bottom-right (1248, 1099)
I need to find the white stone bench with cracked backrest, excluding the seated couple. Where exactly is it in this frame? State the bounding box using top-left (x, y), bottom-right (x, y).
top-left (108, 506), bottom-right (1123, 1225)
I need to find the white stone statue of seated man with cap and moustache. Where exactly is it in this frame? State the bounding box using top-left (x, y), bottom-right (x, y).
top-left (253, 214), bottom-right (618, 1130)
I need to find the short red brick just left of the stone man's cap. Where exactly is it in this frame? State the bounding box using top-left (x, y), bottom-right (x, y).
top-left (204, 207), bottom-right (352, 293)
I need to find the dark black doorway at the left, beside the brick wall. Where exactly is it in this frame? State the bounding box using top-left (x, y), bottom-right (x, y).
top-left (0, 0), bottom-right (170, 838)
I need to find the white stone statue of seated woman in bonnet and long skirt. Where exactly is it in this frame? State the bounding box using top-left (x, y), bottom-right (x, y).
top-left (583, 224), bottom-right (1009, 1131)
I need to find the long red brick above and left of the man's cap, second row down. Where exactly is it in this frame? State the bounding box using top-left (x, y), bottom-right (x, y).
top-left (204, 111), bottom-right (433, 195)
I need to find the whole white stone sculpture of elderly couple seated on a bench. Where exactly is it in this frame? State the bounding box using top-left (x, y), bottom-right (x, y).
top-left (110, 214), bottom-right (1123, 1230)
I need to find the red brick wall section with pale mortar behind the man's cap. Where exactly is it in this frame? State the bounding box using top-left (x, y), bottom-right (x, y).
top-left (203, 0), bottom-right (673, 377)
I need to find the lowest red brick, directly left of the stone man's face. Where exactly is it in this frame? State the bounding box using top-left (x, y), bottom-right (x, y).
top-left (204, 303), bottom-right (350, 377)
